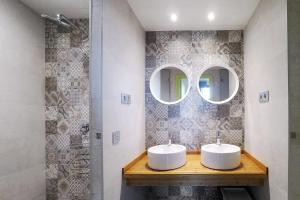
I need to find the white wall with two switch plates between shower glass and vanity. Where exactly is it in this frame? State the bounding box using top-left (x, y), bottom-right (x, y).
top-left (103, 0), bottom-right (145, 200)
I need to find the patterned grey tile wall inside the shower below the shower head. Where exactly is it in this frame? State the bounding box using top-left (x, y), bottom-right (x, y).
top-left (45, 19), bottom-right (89, 200)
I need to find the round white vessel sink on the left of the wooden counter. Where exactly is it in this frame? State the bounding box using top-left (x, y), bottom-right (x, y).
top-left (148, 144), bottom-right (186, 170)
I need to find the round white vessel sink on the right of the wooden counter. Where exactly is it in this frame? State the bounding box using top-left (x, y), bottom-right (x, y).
top-left (201, 144), bottom-right (241, 170)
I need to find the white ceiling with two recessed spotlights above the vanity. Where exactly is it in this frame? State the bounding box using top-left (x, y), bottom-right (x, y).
top-left (127, 0), bottom-right (260, 31)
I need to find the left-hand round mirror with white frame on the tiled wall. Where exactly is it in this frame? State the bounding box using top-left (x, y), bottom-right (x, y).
top-left (150, 64), bottom-right (190, 104)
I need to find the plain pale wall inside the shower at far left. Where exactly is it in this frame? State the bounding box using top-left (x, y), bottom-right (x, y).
top-left (0, 0), bottom-right (45, 200)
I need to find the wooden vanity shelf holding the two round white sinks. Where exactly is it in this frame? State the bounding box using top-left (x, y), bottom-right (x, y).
top-left (122, 151), bottom-right (268, 186)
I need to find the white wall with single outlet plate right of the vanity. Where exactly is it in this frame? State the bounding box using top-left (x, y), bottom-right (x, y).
top-left (245, 0), bottom-right (288, 200)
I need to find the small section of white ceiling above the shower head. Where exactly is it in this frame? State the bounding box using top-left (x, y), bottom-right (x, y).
top-left (20, 0), bottom-right (89, 18)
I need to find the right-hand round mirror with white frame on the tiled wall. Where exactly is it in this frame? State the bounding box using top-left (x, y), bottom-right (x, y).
top-left (198, 66), bottom-right (239, 104)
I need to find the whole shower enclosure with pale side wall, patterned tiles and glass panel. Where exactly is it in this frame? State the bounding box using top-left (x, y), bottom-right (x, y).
top-left (0, 0), bottom-right (102, 200)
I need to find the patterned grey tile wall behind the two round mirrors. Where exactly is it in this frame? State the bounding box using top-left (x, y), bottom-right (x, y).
top-left (145, 31), bottom-right (244, 200)
